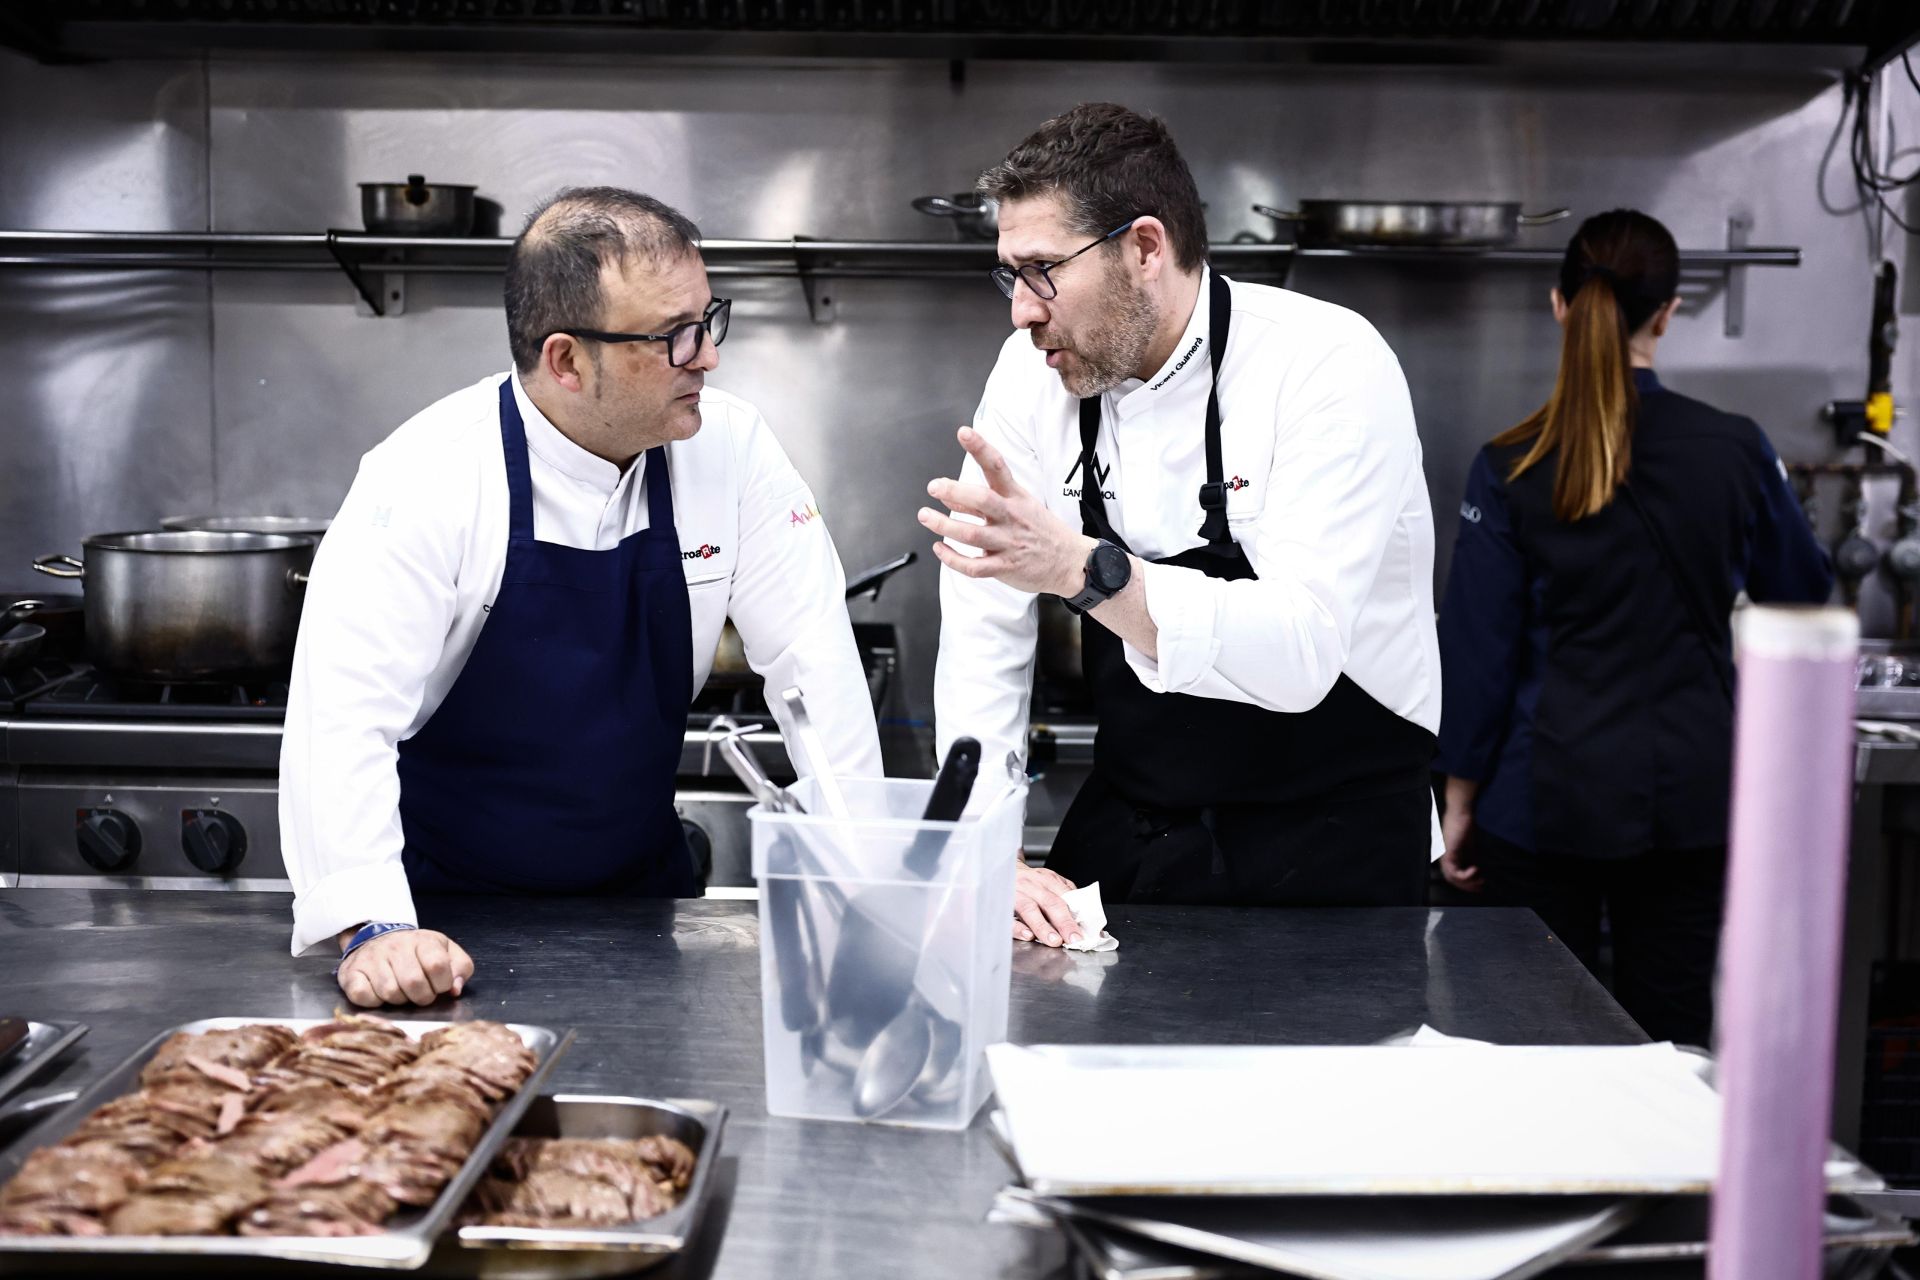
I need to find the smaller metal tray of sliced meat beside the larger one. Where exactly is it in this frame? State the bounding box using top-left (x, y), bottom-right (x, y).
top-left (459, 1094), bottom-right (726, 1259)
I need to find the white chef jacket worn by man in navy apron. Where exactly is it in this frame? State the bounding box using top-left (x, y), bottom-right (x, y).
top-left (280, 374), bottom-right (881, 956)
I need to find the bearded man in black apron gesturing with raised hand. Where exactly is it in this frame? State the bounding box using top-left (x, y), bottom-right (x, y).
top-left (920, 104), bottom-right (1440, 946)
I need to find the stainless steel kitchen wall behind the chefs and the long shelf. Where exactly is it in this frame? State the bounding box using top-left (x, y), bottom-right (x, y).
top-left (0, 56), bottom-right (1920, 716)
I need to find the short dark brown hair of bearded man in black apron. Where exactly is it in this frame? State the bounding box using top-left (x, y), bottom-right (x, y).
top-left (975, 102), bottom-right (1206, 271)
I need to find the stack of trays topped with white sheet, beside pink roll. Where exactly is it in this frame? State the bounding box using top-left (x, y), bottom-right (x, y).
top-left (989, 1032), bottom-right (1910, 1280)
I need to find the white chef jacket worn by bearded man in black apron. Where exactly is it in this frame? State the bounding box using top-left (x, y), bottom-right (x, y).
top-left (933, 271), bottom-right (1440, 831)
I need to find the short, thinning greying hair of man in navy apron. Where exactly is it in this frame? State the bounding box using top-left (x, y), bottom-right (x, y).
top-left (507, 186), bottom-right (701, 372)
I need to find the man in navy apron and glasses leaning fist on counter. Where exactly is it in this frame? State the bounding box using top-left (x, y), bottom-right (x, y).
top-left (280, 188), bottom-right (881, 1006)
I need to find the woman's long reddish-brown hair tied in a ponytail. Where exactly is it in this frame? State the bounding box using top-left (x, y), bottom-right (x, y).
top-left (1494, 209), bottom-right (1680, 520)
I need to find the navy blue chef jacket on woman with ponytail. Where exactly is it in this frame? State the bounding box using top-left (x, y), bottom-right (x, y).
top-left (1436, 368), bottom-right (1834, 858)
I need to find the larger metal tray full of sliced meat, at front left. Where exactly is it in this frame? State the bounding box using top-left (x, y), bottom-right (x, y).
top-left (0, 1015), bottom-right (572, 1268)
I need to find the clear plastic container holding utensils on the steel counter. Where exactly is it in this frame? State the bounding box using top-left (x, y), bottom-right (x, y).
top-left (747, 771), bottom-right (1027, 1128)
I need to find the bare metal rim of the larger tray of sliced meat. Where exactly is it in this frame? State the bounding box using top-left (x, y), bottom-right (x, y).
top-left (0, 1017), bottom-right (574, 1270)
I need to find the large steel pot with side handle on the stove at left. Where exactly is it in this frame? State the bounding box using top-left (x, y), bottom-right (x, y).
top-left (33, 530), bottom-right (315, 681)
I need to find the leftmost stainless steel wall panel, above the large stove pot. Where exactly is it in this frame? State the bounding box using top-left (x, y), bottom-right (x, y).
top-left (0, 54), bottom-right (215, 585)
